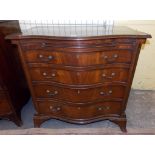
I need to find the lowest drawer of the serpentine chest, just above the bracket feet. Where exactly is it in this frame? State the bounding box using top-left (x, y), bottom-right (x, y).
top-left (37, 101), bottom-right (122, 119)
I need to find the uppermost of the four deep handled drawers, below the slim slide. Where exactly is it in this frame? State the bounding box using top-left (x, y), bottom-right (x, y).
top-left (24, 50), bottom-right (132, 66)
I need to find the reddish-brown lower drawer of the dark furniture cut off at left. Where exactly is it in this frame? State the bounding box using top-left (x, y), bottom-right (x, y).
top-left (0, 94), bottom-right (11, 115)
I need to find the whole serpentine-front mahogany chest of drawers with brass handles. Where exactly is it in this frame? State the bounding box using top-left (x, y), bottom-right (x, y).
top-left (7, 24), bottom-right (151, 132)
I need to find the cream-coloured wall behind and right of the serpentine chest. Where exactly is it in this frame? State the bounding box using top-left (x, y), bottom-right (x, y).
top-left (115, 20), bottom-right (155, 90)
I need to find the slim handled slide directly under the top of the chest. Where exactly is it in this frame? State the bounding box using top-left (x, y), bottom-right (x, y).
top-left (21, 39), bottom-right (135, 50)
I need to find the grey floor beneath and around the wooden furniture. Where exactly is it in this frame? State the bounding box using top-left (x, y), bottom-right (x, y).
top-left (0, 90), bottom-right (155, 134)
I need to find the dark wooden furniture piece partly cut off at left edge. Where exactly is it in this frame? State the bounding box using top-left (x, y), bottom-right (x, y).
top-left (0, 21), bottom-right (30, 126)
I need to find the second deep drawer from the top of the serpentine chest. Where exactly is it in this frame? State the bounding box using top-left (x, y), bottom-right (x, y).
top-left (29, 67), bottom-right (129, 85)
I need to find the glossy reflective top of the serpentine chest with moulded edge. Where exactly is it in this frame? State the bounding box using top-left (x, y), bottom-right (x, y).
top-left (6, 25), bottom-right (151, 40)
